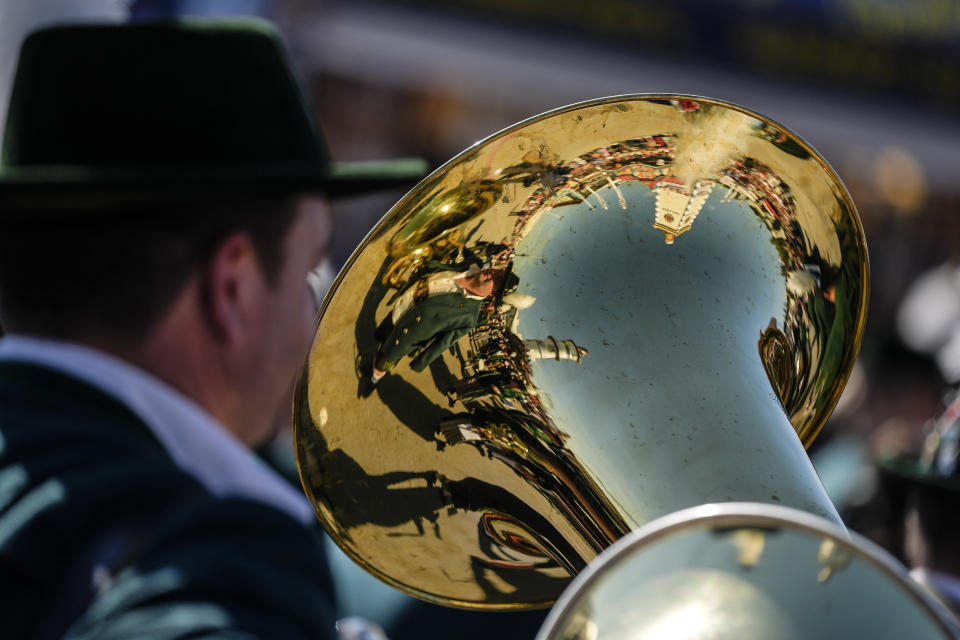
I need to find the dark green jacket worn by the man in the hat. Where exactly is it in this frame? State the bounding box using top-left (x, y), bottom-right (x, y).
top-left (0, 362), bottom-right (334, 640)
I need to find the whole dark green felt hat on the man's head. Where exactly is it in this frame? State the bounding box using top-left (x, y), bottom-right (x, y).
top-left (0, 19), bottom-right (426, 216)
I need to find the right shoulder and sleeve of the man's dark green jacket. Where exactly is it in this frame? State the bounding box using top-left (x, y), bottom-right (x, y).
top-left (66, 498), bottom-right (335, 640)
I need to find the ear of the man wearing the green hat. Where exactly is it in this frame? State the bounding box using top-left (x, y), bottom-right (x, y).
top-left (203, 232), bottom-right (266, 343)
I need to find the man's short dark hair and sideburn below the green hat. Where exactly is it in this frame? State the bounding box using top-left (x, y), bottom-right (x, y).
top-left (0, 198), bottom-right (296, 346)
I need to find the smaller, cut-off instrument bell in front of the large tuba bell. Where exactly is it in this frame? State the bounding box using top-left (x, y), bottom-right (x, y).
top-left (537, 503), bottom-right (960, 640)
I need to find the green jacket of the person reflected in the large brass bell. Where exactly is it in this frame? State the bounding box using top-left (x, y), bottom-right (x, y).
top-left (380, 293), bottom-right (483, 371)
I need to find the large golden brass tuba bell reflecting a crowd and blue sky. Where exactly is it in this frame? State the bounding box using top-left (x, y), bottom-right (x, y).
top-left (294, 96), bottom-right (868, 609)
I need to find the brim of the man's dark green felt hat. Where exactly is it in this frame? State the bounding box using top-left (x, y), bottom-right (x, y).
top-left (0, 158), bottom-right (428, 214)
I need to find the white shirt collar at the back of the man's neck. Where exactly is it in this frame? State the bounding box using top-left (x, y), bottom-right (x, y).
top-left (0, 335), bottom-right (316, 525)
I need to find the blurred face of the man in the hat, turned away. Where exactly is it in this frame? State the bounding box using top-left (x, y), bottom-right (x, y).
top-left (244, 197), bottom-right (330, 446)
